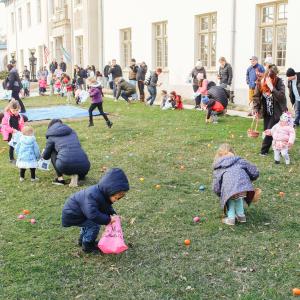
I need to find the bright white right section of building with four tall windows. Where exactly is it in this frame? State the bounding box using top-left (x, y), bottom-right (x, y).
top-left (103, 0), bottom-right (300, 104)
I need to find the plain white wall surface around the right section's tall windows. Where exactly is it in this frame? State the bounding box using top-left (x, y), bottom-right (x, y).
top-left (103, 0), bottom-right (292, 104)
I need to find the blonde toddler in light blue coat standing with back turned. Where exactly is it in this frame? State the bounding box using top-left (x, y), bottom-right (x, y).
top-left (16, 126), bottom-right (40, 182)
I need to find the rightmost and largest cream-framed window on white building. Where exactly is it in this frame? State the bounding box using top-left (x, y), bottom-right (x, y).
top-left (258, 0), bottom-right (288, 70)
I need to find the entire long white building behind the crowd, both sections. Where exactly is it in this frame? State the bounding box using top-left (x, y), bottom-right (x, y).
top-left (0, 0), bottom-right (300, 104)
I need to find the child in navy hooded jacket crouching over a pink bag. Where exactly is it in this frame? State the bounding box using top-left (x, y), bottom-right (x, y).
top-left (62, 168), bottom-right (129, 253)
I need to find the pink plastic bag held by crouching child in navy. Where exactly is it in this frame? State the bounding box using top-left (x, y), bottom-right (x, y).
top-left (98, 217), bottom-right (128, 254)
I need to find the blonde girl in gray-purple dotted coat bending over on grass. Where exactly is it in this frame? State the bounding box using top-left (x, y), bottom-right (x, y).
top-left (213, 144), bottom-right (259, 225)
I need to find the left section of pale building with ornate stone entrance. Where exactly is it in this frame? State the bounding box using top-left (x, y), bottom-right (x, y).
top-left (1, 0), bottom-right (103, 78)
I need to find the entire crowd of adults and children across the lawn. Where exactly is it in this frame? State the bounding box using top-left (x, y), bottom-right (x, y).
top-left (0, 52), bottom-right (300, 252)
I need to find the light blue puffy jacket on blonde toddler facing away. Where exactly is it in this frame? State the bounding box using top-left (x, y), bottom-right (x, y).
top-left (15, 135), bottom-right (40, 162)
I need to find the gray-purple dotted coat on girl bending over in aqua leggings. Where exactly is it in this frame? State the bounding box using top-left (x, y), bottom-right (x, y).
top-left (213, 156), bottom-right (259, 209)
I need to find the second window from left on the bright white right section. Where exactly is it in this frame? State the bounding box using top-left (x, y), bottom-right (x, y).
top-left (152, 21), bottom-right (169, 71)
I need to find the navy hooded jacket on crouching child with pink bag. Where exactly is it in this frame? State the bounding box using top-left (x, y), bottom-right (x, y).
top-left (62, 168), bottom-right (129, 227)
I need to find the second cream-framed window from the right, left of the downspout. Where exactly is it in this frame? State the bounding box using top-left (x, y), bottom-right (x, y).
top-left (195, 11), bottom-right (218, 70)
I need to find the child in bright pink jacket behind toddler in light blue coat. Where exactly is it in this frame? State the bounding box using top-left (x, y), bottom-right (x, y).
top-left (1, 100), bottom-right (24, 164)
